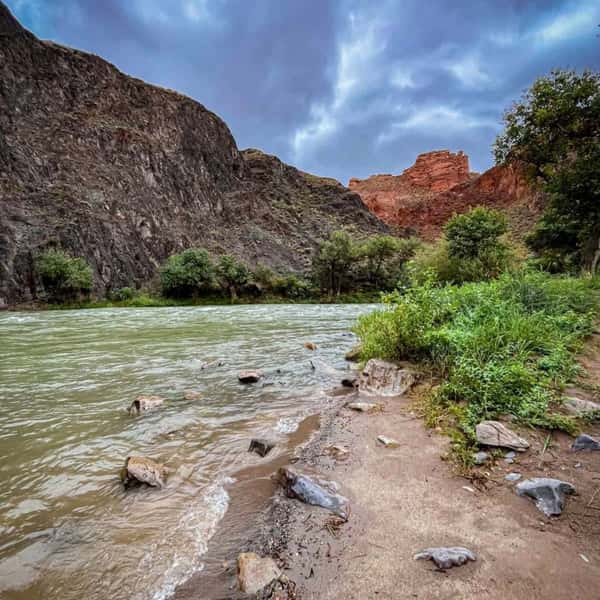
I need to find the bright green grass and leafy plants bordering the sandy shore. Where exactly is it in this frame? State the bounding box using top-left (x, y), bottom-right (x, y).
top-left (356, 270), bottom-right (596, 468)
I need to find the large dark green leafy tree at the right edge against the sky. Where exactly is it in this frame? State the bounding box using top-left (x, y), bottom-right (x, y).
top-left (494, 71), bottom-right (600, 270)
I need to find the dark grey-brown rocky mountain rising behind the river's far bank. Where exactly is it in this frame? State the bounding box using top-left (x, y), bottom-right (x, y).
top-left (0, 1), bottom-right (387, 303)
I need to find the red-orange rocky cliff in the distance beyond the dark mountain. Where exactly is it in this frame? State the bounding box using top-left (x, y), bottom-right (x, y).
top-left (349, 151), bottom-right (542, 239)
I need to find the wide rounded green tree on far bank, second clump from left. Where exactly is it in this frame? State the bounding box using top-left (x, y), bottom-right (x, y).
top-left (160, 248), bottom-right (215, 298)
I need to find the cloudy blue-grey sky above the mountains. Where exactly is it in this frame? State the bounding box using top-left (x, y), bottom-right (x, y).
top-left (4, 0), bottom-right (600, 183)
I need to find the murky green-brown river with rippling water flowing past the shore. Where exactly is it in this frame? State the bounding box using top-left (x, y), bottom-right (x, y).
top-left (0, 305), bottom-right (373, 600)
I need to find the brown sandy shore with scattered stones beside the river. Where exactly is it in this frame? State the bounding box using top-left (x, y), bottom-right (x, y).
top-left (177, 388), bottom-right (600, 600)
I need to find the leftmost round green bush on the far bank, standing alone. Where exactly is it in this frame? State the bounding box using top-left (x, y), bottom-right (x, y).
top-left (36, 250), bottom-right (93, 302)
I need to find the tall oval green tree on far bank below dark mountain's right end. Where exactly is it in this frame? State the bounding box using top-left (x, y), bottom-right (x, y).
top-left (312, 230), bottom-right (358, 296)
